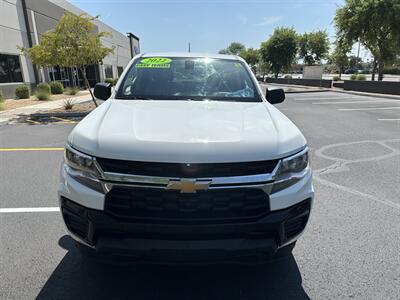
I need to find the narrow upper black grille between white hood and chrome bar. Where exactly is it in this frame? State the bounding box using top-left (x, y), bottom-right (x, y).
top-left (96, 157), bottom-right (278, 178)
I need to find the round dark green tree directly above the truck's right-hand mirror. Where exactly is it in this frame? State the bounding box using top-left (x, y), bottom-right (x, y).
top-left (260, 27), bottom-right (297, 77)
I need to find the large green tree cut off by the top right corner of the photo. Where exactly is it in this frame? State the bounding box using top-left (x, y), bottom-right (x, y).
top-left (335, 0), bottom-right (400, 80)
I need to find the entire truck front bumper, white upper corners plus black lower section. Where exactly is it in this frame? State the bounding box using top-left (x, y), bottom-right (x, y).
top-left (58, 159), bottom-right (314, 261)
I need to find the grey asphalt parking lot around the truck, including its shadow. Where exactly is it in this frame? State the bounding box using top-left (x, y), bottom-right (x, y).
top-left (0, 92), bottom-right (400, 300)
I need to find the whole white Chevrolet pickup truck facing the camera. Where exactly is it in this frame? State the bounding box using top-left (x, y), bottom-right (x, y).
top-left (58, 53), bottom-right (314, 261)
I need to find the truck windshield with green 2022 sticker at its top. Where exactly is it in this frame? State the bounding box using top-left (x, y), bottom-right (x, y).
top-left (117, 57), bottom-right (261, 102)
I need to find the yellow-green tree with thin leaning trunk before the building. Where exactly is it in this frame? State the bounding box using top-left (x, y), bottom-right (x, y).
top-left (20, 13), bottom-right (114, 106)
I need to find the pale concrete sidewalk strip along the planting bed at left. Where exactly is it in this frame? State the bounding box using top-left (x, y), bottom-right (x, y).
top-left (0, 94), bottom-right (92, 124)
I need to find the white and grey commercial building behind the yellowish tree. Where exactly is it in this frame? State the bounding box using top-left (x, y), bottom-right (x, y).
top-left (0, 0), bottom-right (140, 97)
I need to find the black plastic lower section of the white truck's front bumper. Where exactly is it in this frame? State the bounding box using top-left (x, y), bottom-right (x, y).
top-left (60, 197), bottom-right (312, 260)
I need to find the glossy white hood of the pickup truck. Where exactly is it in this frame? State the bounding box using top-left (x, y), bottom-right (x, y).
top-left (69, 99), bottom-right (306, 163)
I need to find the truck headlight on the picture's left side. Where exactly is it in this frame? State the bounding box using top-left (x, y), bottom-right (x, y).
top-left (64, 145), bottom-right (103, 192)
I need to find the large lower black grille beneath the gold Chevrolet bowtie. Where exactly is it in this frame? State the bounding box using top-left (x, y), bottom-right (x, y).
top-left (104, 187), bottom-right (269, 223)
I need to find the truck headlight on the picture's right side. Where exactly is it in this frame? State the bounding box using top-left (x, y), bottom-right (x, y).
top-left (271, 148), bottom-right (309, 193)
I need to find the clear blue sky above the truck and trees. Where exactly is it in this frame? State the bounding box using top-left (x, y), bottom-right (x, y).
top-left (69, 0), bottom-right (363, 57)
